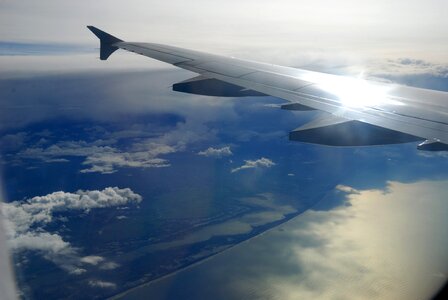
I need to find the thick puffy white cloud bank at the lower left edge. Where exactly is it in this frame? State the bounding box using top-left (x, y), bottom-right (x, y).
top-left (0, 187), bottom-right (142, 274)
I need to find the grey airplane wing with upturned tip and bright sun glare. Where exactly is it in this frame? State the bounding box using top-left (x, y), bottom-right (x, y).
top-left (87, 26), bottom-right (448, 151)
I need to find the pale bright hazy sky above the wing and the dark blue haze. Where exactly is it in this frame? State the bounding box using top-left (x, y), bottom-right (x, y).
top-left (0, 0), bottom-right (448, 75)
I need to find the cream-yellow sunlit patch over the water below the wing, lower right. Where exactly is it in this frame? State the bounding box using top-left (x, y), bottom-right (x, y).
top-left (260, 181), bottom-right (448, 299)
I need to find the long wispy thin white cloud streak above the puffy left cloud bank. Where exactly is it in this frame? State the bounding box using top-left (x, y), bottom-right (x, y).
top-left (16, 116), bottom-right (214, 174)
